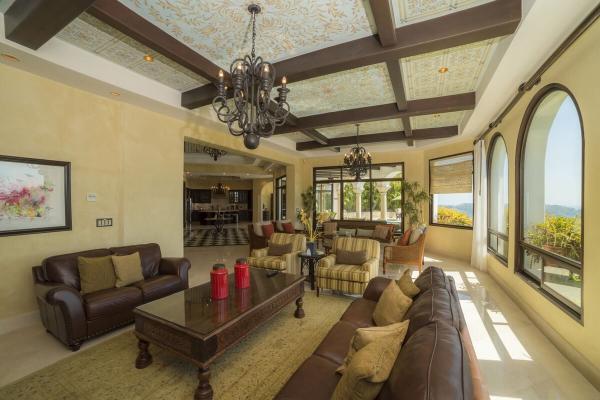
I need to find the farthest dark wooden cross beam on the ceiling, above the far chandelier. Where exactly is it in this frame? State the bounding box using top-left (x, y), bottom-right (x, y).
top-left (296, 126), bottom-right (458, 151)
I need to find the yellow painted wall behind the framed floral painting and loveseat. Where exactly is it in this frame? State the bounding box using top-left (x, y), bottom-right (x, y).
top-left (0, 65), bottom-right (298, 320)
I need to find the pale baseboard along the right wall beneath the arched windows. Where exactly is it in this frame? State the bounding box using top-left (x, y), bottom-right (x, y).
top-left (488, 269), bottom-right (600, 390)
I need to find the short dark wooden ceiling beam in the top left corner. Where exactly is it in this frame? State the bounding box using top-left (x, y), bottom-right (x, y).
top-left (4, 0), bottom-right (94, 50)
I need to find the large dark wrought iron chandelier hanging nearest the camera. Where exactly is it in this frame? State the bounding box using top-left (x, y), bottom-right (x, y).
top-left (212, 4), bottom-right (290, 150)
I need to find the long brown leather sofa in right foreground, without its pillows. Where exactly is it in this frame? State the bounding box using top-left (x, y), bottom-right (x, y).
top-left (275, 267), bottom-right (489, 400)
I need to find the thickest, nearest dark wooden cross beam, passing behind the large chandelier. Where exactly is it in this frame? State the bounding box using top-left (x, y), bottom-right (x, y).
top-left (181, 0), bottom-right (521, 109)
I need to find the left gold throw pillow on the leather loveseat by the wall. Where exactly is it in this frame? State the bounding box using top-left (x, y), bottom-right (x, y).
top-left (77, 256), bottom-right (117, 294)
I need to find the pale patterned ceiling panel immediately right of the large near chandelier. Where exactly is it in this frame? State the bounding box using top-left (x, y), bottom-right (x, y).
top-left (288, 63), bottom-right (396, 117)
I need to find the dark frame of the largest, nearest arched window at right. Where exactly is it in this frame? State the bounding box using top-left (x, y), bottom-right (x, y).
top-left (514, 83), bottom-right (585, 325)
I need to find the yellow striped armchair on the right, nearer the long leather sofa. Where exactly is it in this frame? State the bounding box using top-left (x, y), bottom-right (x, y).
top-left (316, 237), bottom-right (380, 296)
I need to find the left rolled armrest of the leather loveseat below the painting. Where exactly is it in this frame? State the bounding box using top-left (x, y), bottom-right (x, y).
top-left (35, 282), bottom-right (87, 350)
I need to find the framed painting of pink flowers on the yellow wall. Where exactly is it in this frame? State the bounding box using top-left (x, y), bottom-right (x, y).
top-left (0, 155), bottom-right (71, 236)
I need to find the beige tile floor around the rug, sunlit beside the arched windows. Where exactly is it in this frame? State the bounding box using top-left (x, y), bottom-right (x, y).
top-left (0, 242), bottom-right (600, 400)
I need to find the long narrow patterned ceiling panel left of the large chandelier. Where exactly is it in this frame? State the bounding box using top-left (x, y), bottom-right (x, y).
top-left (58, 14), bottom-right (209, 91)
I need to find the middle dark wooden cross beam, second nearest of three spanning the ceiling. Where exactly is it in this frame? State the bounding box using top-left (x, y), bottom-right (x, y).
top-left (275, 92), bottom-right (475, 134)
